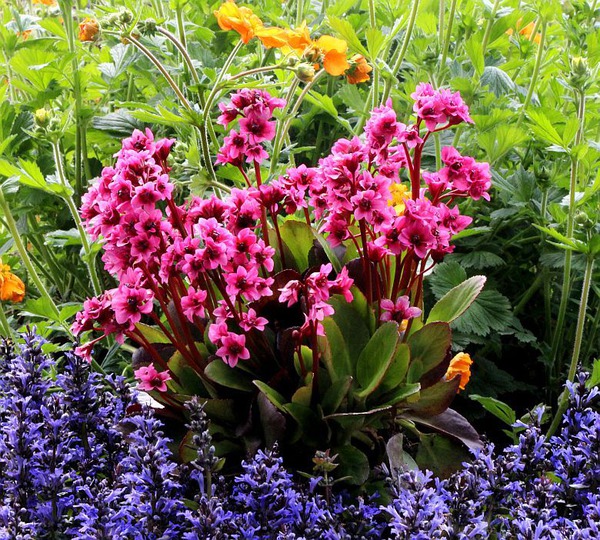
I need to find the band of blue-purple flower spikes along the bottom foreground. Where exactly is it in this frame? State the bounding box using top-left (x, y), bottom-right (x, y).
top-left (0, 333), bottom-right (600, 540)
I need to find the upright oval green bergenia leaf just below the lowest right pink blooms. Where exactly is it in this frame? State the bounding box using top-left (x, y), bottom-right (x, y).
top-left (356, 321), bottom-right (398, 398)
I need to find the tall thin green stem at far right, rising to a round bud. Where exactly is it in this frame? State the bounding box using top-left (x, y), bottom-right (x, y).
top-left (551, 92), bottom-right (585, 369)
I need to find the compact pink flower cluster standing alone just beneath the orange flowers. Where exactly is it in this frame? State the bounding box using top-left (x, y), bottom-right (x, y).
top-left (217, 88), bottom-right (285, 168)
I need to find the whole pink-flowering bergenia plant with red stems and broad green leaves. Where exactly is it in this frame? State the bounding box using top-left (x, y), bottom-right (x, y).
top-left (73, 83), bottom-right (491, 476)
